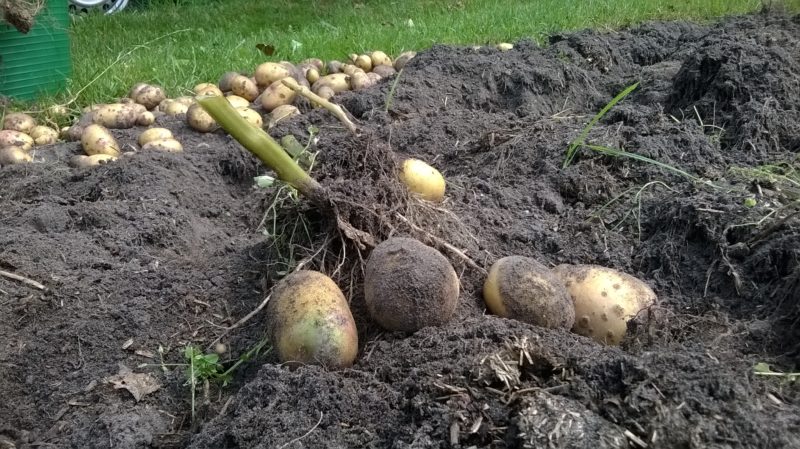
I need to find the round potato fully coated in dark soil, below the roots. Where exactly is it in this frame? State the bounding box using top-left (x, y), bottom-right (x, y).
top-left (364, 237), bottom-right (459, 332)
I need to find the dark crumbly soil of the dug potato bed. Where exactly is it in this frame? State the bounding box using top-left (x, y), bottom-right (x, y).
top-left (0, 10), bottom-right (800, 449)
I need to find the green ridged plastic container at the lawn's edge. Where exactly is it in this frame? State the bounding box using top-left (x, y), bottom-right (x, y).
top-left (0, 0), bottom-right (72, 100)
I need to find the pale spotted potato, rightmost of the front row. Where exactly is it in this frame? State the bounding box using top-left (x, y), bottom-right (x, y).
top-left (552, 265), bottom-right (656, 345)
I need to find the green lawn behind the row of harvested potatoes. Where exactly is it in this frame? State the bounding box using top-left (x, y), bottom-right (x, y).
top-left (59, 0), bottom-right (800, 105)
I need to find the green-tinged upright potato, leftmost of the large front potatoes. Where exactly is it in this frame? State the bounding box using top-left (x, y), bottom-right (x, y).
top-left (267, 270), bottom-right (358, 369)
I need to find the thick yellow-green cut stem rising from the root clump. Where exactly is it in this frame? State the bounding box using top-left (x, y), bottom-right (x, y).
top-left (197, 96), bottom-right (329, 207)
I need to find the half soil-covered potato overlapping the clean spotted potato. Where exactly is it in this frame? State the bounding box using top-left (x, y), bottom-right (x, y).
top-left (483, 256), bottom-right (575, 329)
